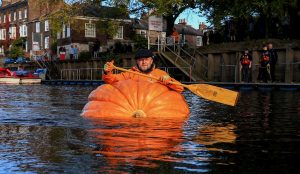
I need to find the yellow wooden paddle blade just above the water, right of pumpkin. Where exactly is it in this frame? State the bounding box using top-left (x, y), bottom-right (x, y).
top-left (184, 84), bottom-right (239, 106)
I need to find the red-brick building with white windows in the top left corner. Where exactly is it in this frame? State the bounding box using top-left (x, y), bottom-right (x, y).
top-left (0, 0), bottom-right (64, 56)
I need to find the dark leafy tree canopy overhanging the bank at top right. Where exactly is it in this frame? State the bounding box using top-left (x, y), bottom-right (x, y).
top-left (200, 0), bottom-right (297, 37)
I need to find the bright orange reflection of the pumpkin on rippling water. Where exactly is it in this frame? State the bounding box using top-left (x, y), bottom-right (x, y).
top-left (90, 118), bottom-right (185, 169)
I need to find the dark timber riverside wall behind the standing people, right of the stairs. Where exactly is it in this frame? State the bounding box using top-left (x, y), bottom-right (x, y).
top-left (199, 40), bottom-right (300, 83)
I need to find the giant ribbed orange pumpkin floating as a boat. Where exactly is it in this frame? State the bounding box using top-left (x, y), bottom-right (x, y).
top-left (82, 80), bottom-right (189, 119)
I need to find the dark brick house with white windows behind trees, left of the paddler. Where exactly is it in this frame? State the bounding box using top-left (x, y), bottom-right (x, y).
top-left (57, 4), bottom-right (133, 59)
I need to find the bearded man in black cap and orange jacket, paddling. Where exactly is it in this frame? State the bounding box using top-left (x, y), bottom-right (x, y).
top-left (103, 49), bottom-right (184, 92)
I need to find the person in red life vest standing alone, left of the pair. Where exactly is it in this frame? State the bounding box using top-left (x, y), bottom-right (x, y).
top-left (240, 49), bottom-right (252, 83)
